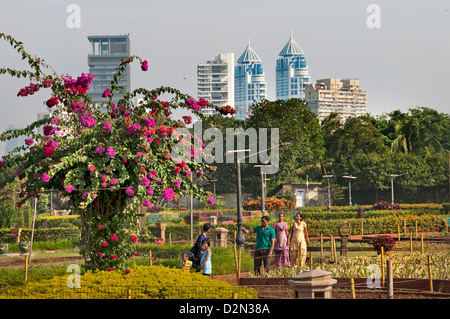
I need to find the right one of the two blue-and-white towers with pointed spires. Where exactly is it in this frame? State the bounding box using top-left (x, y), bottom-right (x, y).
top-left (275, 30), bottom-right (311, 100)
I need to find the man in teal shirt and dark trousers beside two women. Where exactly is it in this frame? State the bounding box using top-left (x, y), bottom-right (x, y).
top-left (241, 216), bottom-right (276, 274)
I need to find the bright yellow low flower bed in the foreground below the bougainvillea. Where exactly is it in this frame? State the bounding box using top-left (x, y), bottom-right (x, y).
top-left (0, 266), bottom-right (257, 299)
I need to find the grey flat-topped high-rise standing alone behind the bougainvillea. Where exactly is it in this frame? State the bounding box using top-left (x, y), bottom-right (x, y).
top-left (88, 34), bottom-right (131, 103)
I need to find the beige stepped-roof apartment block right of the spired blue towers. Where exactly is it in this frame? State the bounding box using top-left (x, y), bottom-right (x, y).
top-left (305, 78), bottom-right (367, 122)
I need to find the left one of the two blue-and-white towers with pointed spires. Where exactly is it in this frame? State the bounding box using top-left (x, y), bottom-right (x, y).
top-left (234, 40), bottom-right (267, 120)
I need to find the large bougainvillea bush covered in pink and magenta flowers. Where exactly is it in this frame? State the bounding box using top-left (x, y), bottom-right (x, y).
top-left (0, 33), bottom-right (232, 270)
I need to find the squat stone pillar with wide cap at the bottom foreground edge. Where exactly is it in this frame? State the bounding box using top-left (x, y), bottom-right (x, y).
top-left (288, 269), bottom-right (337, 299)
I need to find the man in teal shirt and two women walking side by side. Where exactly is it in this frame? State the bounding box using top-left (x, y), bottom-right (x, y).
top-left (241, 213), bottom-right (309, 274)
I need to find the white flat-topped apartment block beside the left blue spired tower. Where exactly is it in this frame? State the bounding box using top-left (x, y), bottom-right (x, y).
top-left (197, 53), bottom-right (234, 115)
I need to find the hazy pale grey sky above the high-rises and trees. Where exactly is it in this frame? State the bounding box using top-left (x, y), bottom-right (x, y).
top-left (0, 0), bottom-right (450, 155)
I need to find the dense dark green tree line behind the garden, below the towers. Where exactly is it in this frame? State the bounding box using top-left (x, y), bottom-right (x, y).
top-left (199, 99), bottom-right (450, 205)
